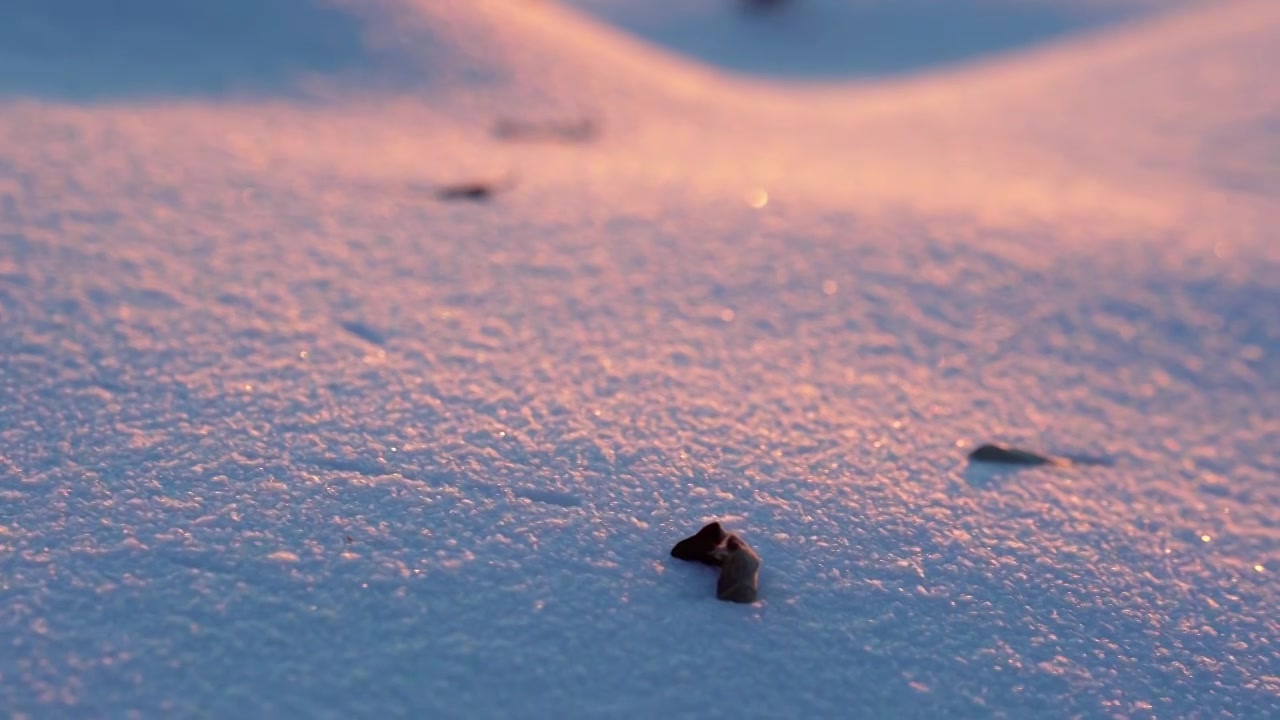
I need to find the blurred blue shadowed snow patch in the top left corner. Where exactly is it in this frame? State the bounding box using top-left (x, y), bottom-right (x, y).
top-left (0, 0), bottom-right (394, 100)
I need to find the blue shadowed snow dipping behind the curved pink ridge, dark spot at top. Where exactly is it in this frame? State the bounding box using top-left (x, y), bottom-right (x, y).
top-left (560, 0), bottom-right (1152, 79)
